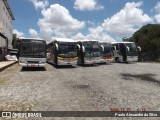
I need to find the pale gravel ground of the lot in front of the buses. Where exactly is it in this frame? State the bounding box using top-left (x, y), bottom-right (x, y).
top-left (0, 63), bottom-right (160, 120)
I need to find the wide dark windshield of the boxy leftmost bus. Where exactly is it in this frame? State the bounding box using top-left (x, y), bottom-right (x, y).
top-left (20, 42), bottom-right (46, 58)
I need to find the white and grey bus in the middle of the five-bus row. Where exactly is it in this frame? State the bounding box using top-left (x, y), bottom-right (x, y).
top-left (77, 40), bottom-right (102, 65)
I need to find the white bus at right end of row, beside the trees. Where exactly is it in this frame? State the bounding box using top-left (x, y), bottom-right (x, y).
top-left (112, 42), bottom-right (141, 62)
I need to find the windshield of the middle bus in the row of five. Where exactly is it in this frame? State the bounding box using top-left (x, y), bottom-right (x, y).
top-left (82, 41), bottom-right (100, 57)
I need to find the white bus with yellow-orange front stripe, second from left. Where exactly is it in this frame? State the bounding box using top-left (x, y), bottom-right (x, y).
top-left (47, 38), bottom-right (78, 66)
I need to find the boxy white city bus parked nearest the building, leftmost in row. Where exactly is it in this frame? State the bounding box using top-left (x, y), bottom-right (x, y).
top-left (18, 38), bottom-right (46, 67)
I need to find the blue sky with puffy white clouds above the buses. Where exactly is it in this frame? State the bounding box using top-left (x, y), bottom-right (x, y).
top-left (8, 0), bottom-right (160, 42)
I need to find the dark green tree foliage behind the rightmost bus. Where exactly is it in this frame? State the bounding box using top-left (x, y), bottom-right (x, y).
top-left (129, 24), bottom-right (160, 61)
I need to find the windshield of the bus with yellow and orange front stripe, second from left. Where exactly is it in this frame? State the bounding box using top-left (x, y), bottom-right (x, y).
top-left (58, 42), bottom-right (77, 58)
